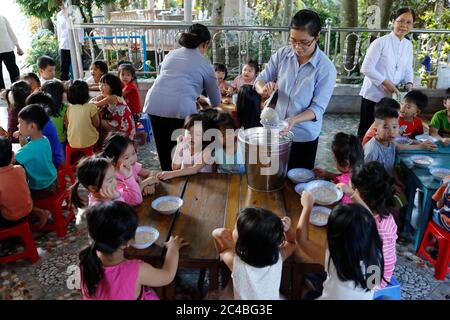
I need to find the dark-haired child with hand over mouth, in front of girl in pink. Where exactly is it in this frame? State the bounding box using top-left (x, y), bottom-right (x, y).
top-left (72, 156), bottom-right (124, 208)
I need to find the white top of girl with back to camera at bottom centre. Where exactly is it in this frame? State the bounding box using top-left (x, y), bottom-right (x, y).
top-left (231, 254), bottom-right (283, 300)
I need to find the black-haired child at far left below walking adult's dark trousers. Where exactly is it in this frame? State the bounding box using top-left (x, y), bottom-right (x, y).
top-left (4, 80), bottom-right (31, 143)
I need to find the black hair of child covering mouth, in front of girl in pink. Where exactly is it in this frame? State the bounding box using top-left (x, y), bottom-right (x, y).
top-left (72, 155), bottom-right (112, 208)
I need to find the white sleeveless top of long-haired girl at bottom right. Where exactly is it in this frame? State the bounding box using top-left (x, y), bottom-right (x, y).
top-left (317, 249), bottom-right (374, 300)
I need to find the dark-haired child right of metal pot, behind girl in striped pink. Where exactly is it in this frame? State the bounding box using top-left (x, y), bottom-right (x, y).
top-left (314, 132), bottom-right (364, 203)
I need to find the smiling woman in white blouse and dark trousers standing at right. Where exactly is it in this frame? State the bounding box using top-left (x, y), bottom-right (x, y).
top-left (358, 8), bottom-right (416, 139)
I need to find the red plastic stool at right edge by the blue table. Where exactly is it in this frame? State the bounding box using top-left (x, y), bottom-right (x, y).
top-left (417, 221), bottom-right (450, 280)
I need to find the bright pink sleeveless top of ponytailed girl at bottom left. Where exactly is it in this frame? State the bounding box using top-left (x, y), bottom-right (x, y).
top-left (81, 260), bottom-right (159, 300)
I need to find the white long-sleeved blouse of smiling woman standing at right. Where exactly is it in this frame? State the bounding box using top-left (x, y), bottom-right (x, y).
top-left (359, 32), bottom-right (414, 102)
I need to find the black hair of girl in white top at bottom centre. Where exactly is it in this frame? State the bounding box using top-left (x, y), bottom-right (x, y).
top-left (236, 207), bottom-right (284, 268)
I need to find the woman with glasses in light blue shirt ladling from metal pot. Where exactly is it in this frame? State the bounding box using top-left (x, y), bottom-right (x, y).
top-left (255, 10), bottom-right (336, 169)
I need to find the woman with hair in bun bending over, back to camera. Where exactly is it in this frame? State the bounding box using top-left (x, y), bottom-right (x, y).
top-left (144, 23), bottom-right (221, 171)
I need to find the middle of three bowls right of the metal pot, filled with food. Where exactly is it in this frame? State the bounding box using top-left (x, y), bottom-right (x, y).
top-left (295, 180), bottom-right (344, 206)
